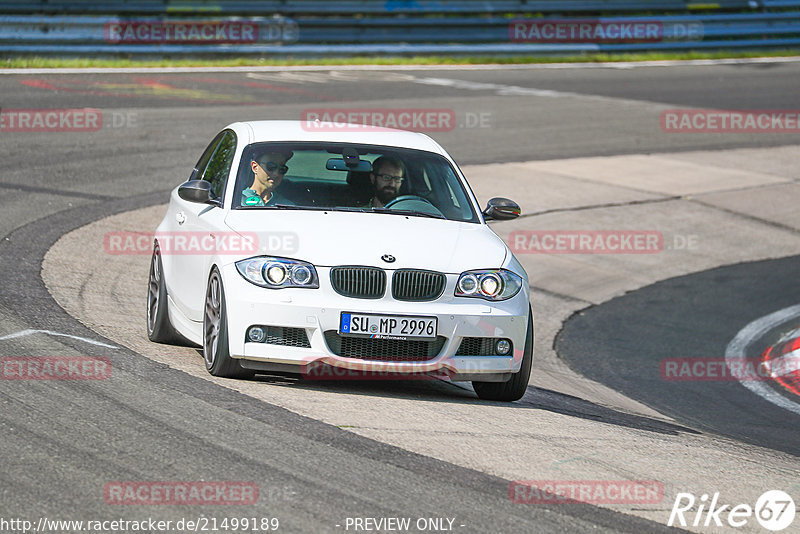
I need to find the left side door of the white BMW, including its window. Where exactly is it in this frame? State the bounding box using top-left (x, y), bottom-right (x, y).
top-left (171, 130), bottom-right (237, 321)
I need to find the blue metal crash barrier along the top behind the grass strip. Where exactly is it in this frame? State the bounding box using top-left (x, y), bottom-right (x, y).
top-left (0, 0), bottom-right (800, 56)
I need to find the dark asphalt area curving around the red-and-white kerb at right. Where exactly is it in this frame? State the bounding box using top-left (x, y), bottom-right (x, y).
top-left (556, 256), bottom-right (800, 456)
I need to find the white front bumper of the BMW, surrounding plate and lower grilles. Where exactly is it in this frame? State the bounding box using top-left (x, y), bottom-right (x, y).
top-left (222, 265), bottom-right (529, 381)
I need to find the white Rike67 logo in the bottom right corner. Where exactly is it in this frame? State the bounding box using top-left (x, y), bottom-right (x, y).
top-left (667, 490), bottom-right (795, 532)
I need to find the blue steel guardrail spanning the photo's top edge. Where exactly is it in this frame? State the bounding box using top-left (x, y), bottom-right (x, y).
top-left (0, 0), bottom-right (800, 56)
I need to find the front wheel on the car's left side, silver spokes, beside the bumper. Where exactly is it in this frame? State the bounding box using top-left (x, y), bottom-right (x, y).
top-left (203, 267), bottom-right (254, 378)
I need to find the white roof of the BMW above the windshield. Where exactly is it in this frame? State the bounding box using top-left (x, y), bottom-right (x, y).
top-left (228, 120), bottom-right (447, 155)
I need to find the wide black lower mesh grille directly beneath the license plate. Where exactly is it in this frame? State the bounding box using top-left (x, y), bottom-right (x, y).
top-left (325, 330), bottom-right (445, 362)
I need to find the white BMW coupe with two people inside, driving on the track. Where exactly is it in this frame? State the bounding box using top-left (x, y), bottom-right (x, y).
top-left (147, 121), bottom-right (533, 401)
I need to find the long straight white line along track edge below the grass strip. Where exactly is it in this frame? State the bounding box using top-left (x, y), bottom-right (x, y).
top-left (0, 57), bottom-right (800, 75)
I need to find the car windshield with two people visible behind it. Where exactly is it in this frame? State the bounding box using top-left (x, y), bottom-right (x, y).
top-left (233, 143), bottom-right (479, 222)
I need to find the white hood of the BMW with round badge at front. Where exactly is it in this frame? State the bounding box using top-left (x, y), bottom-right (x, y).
top-left (225, 209), bottom-right (508, 273)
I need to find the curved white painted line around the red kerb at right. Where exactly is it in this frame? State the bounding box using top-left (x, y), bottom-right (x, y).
top-left (725, 304), bottom-right (800, 415)
